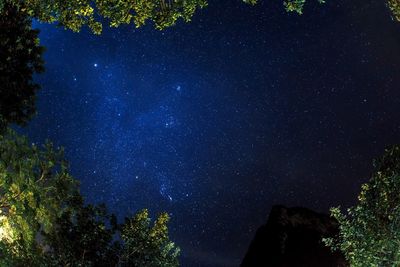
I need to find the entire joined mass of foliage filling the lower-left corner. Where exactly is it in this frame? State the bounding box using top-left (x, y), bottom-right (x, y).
top-left (0, 129), bottom-right (179, 267)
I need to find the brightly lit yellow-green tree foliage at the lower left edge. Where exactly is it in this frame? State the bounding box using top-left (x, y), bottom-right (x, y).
top-left (0, 130), bottom-right (77, 266)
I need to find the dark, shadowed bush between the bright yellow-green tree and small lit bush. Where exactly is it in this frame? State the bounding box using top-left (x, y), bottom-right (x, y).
top-left (45, 203), bottom-right (120, 266)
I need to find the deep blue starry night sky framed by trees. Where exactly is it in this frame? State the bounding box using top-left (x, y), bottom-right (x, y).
top-left (22, 0), bottom-right (400, 267)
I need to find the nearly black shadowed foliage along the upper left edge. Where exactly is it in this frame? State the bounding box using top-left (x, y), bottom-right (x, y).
top-left (0, 3), bottom-right (44, 132)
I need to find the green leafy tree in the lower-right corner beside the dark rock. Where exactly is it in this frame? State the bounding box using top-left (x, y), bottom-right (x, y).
top-left (325, 146), bottom-right (400, 267)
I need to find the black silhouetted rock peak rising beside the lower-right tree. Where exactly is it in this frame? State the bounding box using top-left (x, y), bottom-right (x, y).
top-left (241, 206), bottom-right (348, 267)
